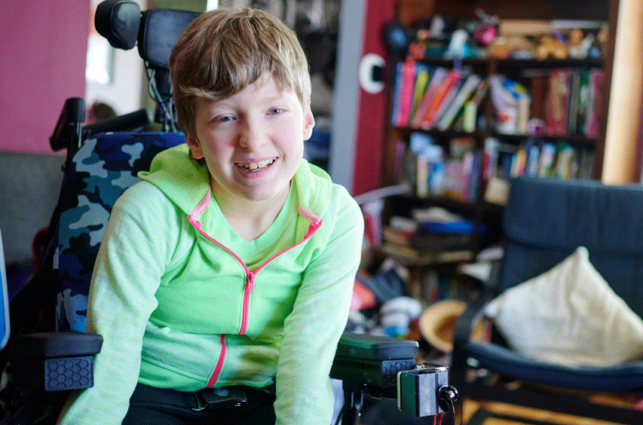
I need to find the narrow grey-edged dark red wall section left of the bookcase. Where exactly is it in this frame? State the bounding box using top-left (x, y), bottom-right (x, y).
top-left (330, 0), bottom-right (395, 195)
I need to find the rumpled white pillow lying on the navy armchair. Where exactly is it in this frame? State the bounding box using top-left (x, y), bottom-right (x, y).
top-left (485, 246), bottom-right (643, 366)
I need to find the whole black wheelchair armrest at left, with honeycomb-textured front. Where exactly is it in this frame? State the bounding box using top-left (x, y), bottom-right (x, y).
top-left (9, 332), bottom-right (103, 391)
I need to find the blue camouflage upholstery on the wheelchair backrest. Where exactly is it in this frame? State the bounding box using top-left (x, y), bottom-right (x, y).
top-left (53, 133), bottom-right (185, 332)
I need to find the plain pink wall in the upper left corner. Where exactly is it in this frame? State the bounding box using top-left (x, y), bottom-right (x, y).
top-left (0, 0), bottom-right (89, 152)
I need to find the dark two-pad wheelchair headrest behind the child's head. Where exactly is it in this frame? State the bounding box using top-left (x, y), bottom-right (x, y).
top-left (94, 0), bottom-right (200, 69)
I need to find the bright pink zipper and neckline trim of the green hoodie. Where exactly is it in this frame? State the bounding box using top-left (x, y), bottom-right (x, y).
top-left (188, 194), bottom-right (322, 388)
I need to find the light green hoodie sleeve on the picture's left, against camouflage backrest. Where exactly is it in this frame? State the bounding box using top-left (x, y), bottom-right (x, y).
top-left (58, 183), bottom-right (178, 425)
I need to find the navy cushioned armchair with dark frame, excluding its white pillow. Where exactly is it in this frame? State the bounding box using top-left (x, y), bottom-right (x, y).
top-left (450, 177), bottom-right (643, 424)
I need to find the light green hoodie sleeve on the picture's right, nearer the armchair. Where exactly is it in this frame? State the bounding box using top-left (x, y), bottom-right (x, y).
top-left (275, 188), bottom-right (364, 425)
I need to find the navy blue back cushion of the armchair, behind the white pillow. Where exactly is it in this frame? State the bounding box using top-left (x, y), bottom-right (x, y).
top-left (499, 177), bottom-right (643, 317)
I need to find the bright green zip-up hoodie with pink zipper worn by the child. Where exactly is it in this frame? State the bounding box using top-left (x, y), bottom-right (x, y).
top-left (59, 145), bottom-right (363, 425)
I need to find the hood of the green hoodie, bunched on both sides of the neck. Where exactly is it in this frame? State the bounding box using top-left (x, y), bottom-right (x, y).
top-left (138, 144), bottom-right (332, 232)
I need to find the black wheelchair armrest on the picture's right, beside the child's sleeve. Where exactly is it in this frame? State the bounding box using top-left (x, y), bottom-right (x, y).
top-left (330, 333), bottom-right (419, 388)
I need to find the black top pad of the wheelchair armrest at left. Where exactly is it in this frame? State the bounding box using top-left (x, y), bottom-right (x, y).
top-left (11, 332), bottom-right (103, 359)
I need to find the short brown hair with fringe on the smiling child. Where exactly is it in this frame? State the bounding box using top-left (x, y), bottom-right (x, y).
top-left (169, 8), bottom-right (311, 137)
